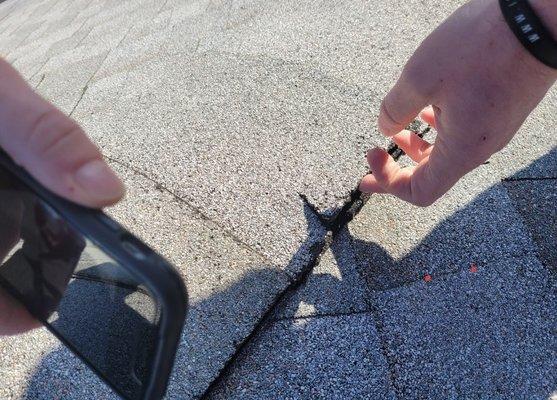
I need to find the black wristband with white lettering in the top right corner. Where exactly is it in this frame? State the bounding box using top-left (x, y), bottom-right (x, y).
top-left (499, 0), bottom-right (557, 69)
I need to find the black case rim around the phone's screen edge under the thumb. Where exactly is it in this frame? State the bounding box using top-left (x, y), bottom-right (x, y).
top-left (0, 150), bottom-right (188, 400)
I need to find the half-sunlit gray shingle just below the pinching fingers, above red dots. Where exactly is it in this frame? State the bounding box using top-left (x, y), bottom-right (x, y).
top-left (349, 165), bottom-right (536, 290)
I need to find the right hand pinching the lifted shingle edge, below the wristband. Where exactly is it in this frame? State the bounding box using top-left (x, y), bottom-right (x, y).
top-left (360, 0), bottom-right (557, 206)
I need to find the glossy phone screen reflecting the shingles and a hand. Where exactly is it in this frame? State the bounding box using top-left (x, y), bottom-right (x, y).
top-left (0, 170), bottom-right (160, 399)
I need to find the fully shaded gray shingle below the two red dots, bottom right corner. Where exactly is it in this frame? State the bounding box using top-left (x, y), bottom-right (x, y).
top-left (375, 257), bottom-right (557, 399)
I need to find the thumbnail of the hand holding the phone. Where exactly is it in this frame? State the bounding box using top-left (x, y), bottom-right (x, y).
top-left (74, 160), bottom-right (124, 202)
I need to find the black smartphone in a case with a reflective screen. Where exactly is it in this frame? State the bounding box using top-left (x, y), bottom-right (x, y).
top-left (0, 150), bottom-right (187, 400)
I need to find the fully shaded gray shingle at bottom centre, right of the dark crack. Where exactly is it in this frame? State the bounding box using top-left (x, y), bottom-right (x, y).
top-left (210, 314), bottom-right (395, 400)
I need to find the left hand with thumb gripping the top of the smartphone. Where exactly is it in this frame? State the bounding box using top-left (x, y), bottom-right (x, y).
top-left (0, 59), bottom-right (124, 334)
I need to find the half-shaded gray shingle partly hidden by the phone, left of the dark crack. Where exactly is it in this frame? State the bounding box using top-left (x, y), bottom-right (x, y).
top-left (0, 164), bottom-right (289, 399)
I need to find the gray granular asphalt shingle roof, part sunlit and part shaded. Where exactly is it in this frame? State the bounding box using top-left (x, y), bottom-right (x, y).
top-left (0, 0), bottom-right (557, 399)
